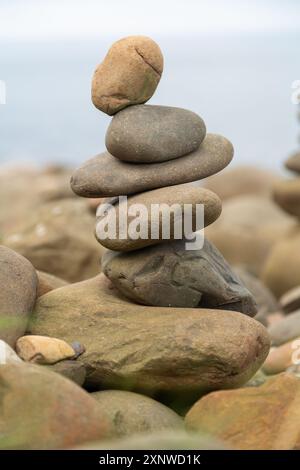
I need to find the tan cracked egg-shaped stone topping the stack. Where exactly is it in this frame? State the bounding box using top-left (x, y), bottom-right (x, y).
top-left (92, 36), bottom-right (163, 116)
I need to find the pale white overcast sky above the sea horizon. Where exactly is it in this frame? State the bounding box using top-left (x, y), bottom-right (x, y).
top-left (0, 0), bottom-right (300, 40)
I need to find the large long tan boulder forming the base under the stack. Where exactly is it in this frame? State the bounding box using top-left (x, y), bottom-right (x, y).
top-left (29, 274), bottom-right (269, 397)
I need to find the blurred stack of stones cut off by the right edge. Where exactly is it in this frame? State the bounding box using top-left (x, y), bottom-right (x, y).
top-left (262, 146), bottom-right (300, 297)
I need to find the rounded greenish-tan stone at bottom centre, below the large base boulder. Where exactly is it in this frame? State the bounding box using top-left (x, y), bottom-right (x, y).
top-left (92, 390), bottom-right (183, 437)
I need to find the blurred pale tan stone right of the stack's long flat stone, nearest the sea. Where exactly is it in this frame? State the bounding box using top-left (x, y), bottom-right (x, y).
top-left (203, 165), bottom-right (278, 201)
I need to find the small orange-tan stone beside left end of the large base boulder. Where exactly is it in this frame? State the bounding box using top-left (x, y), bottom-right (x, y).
top-left (16, 335), bottom-right (75, 364)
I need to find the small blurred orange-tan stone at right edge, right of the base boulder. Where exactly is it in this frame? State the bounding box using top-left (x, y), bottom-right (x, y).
top-left (262, 337), bottom-right (300, 375)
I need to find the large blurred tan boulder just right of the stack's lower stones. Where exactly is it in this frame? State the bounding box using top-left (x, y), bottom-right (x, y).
top-left (205, 195), bottom-right (295, 275)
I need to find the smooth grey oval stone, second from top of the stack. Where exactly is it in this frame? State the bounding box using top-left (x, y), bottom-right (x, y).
top-left (105, 105), bottom-right (206, 163)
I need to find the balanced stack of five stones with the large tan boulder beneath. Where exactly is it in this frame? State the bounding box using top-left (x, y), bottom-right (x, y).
top-left (66, 36), bottom-right (269, 396)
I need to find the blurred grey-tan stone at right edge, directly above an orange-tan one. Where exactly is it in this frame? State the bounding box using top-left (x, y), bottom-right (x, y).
top-left (268, 310), bottom-right (300, 346)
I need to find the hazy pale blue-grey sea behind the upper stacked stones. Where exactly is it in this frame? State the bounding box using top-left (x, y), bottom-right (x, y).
top-left (0, 32), bottom-right (300, 173)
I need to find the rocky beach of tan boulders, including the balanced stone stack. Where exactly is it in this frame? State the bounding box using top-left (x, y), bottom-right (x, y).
top-left (0, 36), bottom-right (300, 450)
